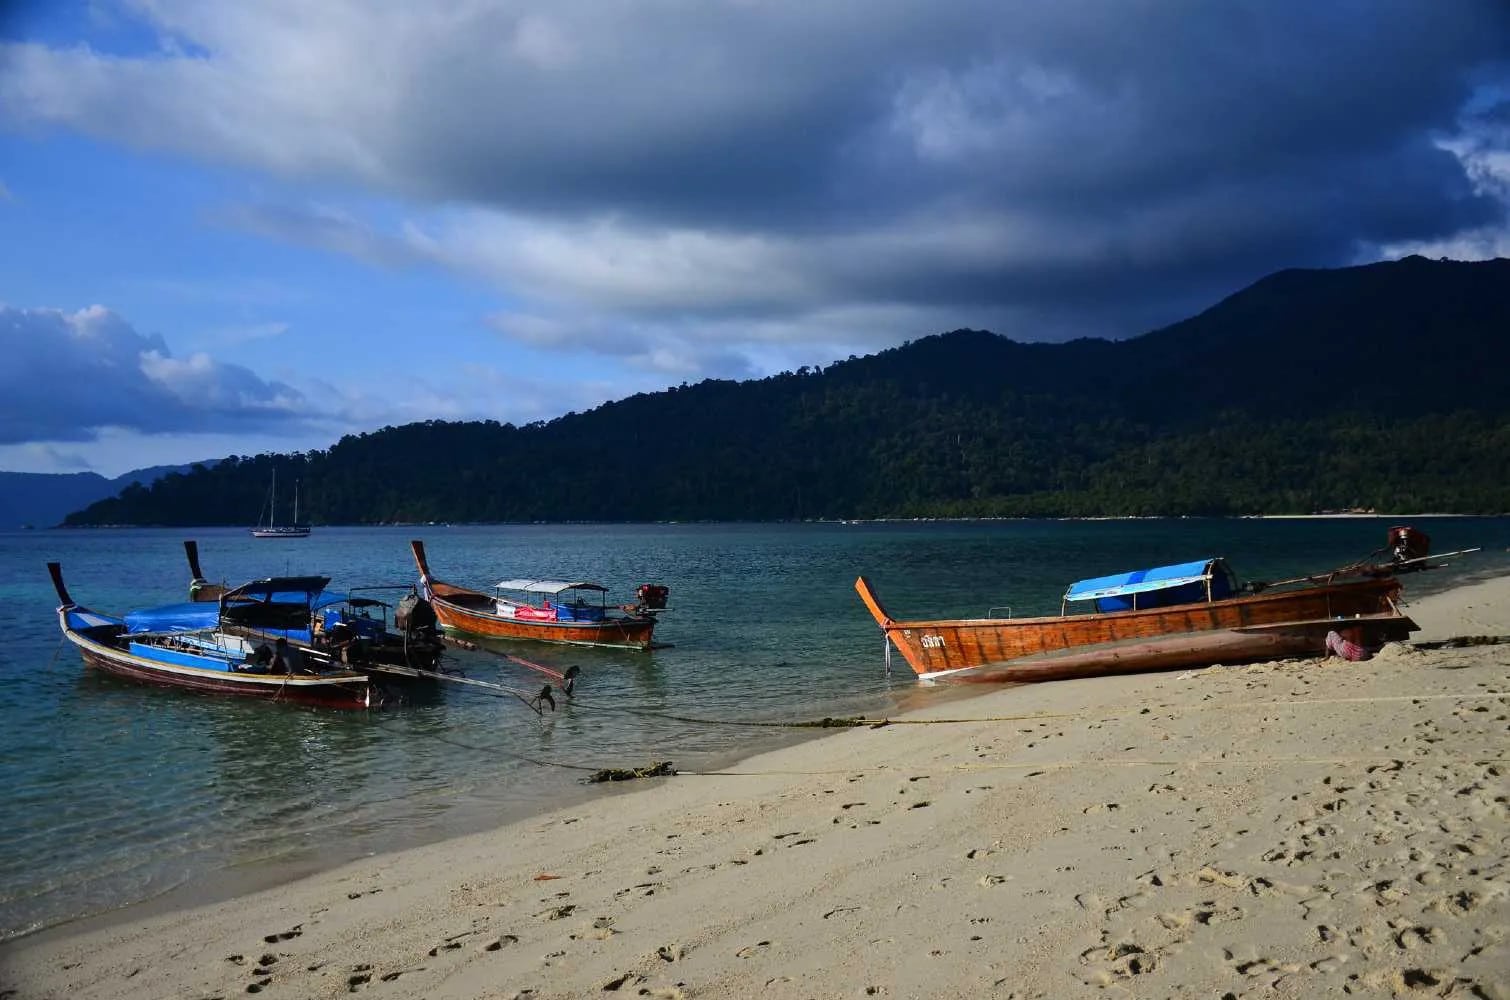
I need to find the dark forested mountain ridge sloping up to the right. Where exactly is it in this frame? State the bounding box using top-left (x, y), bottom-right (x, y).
top-left (68, 257), bottom-right (1510, 526)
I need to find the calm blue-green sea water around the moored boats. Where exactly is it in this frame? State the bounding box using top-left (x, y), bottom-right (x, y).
top-left (0, 518), bottom-right (1510, 937)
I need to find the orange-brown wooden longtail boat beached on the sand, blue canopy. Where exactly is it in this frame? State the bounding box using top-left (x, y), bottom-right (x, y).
top-left (855, 559), bottom-right (1416, 683)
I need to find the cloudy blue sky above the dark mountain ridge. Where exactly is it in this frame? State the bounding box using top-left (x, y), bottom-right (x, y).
top-left (0, 0), bottom-right (1510, 476)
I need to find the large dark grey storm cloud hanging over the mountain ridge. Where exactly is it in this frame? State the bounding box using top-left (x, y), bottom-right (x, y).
top-left (0, 0), bottom-right (1510, 361)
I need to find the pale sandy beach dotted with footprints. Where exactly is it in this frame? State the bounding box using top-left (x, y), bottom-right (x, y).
top-left (0, 577), bottom-right (1510, 1000)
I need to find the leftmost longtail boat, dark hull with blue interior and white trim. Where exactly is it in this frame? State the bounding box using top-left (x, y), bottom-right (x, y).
top-left (47, 562), bottom-right (373, 708)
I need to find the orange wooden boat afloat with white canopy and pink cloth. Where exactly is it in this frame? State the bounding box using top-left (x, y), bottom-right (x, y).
top-left (409, 539), bottom-right (667, 650)
